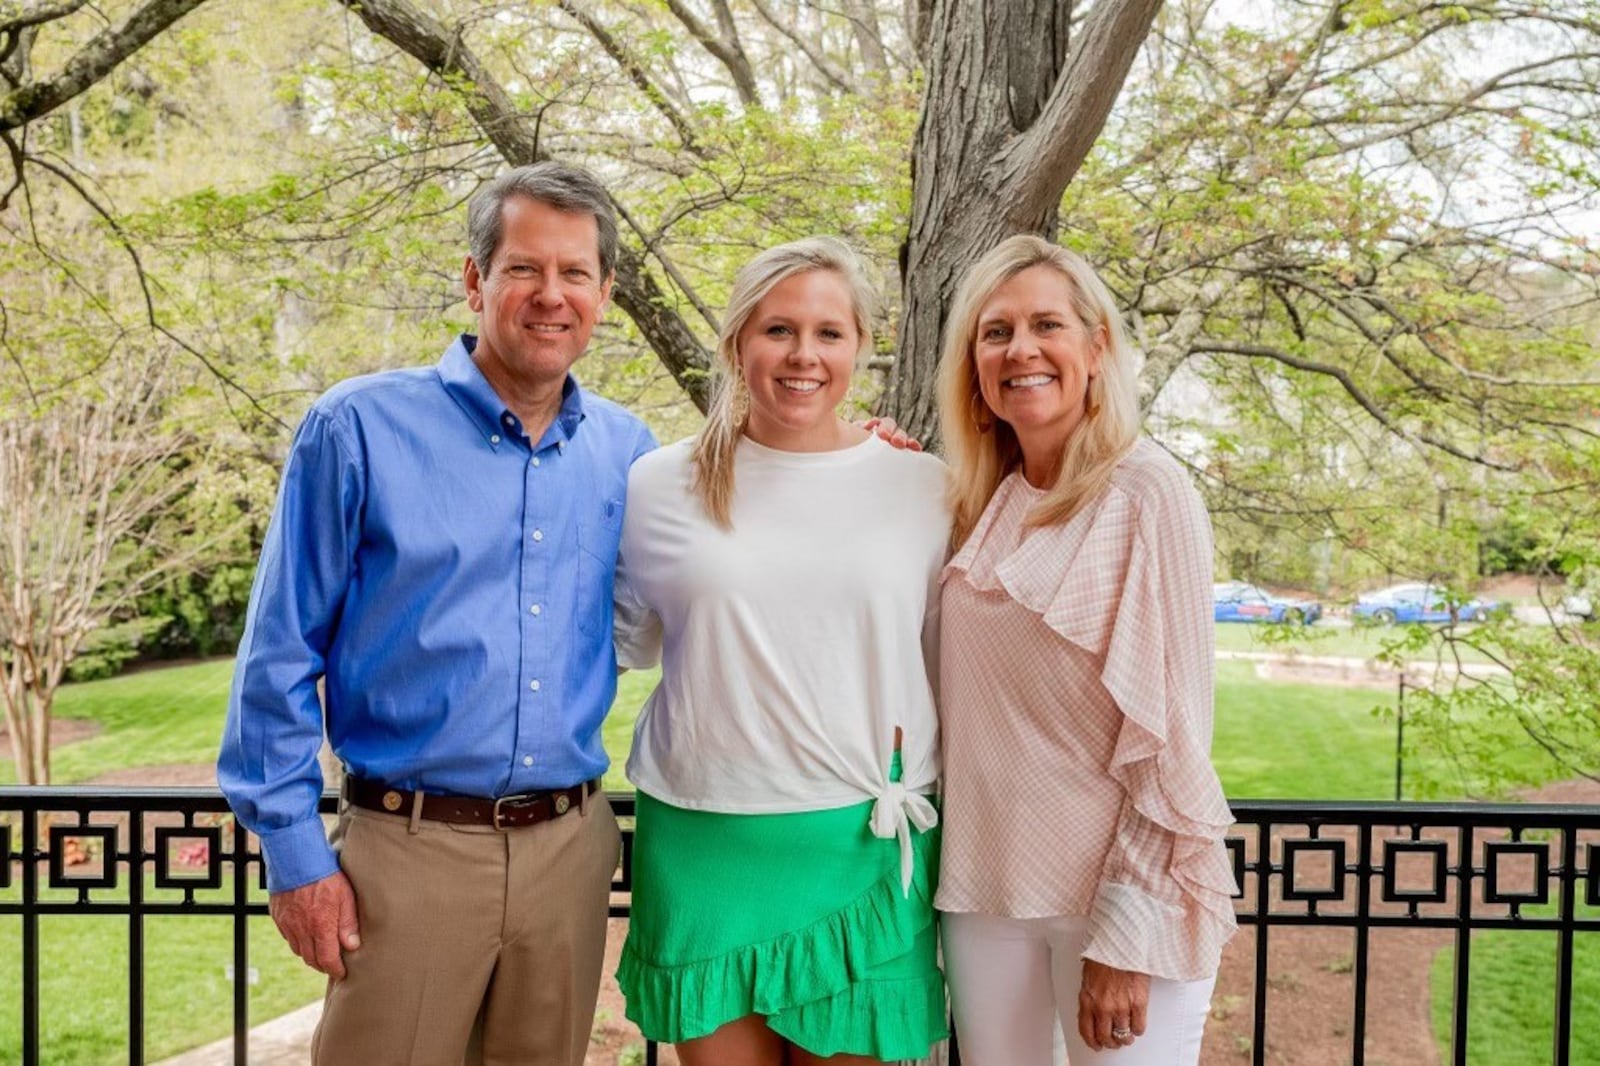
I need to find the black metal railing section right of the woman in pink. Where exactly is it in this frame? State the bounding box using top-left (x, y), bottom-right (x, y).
top-left (1227, 802), bottom-right (1600, 1066)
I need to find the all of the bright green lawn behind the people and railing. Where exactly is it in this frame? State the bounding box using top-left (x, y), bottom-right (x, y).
top-left (0, 643), bottom-right (1600, 1063)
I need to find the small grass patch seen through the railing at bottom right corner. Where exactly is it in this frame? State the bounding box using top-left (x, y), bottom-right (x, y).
top-left (1429, 908), bottom-right (1600, 1066)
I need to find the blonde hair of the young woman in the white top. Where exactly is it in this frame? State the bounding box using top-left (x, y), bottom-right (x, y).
top-left (690, 237), bottom-right (874, 530)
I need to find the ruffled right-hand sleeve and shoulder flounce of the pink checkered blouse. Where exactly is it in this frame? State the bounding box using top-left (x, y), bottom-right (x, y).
top-left (952, 442), bottom-right (1235, 980)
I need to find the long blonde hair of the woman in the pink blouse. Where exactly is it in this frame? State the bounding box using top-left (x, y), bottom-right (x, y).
top-left (939, 234), bottom-right (1139, 546)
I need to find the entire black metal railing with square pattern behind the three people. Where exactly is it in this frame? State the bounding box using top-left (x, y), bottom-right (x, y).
top-left (0, 787), bottom-right (1600, 1066)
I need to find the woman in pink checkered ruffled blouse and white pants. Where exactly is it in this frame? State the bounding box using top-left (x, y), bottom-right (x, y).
top-left (936, 237), bottom-right (1234, 1066)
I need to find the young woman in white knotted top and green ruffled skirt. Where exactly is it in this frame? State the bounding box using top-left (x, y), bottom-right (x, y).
top-left (616, 240), bottom-right (949, 1066)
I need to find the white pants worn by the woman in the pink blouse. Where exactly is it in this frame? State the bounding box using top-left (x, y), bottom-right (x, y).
top-left (941, 914), bottom-right (1216, 1066)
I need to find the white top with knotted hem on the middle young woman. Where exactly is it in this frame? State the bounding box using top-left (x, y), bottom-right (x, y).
top-left (616, 439), bottom-right (949, 838)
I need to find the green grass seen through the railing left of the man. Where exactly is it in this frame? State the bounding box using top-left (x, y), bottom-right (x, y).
top-left (0, 882), bottom-right (325, 1066)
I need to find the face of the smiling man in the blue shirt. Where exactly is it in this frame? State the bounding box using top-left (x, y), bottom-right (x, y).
top-left (462, 197), bottom-right (611, 389)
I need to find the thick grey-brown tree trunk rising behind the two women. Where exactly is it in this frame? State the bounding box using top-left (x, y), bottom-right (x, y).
top-left (886, 0), bottom-right (1160, 442)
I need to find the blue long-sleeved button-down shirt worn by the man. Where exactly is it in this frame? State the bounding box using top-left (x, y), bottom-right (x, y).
top-left (218, 336), bottom-right (656, 892)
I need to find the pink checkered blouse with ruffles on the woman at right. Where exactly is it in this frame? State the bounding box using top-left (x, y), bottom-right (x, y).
top-left (938, 440), bottom-right (1234, 980)
